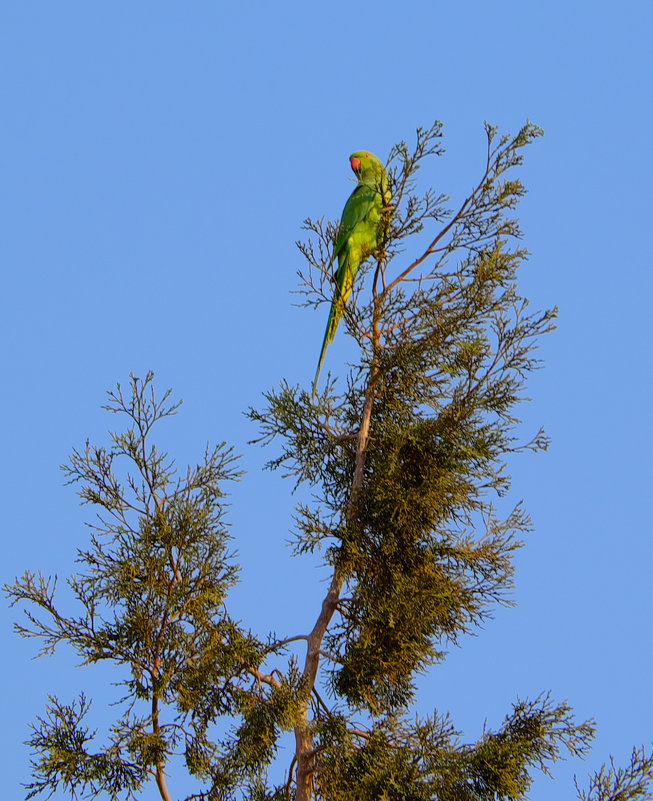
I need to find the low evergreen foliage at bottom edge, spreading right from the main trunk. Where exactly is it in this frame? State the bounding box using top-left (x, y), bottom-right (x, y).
top-left (318, 697), bottom-right (593, 801)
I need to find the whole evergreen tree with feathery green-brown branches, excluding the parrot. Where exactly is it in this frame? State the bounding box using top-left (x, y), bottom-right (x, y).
top-left (5, 123), bottom-right (653, 801)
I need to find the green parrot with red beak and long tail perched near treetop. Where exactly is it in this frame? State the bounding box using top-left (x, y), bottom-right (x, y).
top-left (312, 150), bottom-right (390, 398)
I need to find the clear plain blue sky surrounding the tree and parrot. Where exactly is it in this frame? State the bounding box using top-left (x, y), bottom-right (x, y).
top-left (0, 0), bottom-right (653, 801)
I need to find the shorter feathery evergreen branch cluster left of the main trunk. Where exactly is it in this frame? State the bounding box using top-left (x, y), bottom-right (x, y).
top-left (5, 374), bottom-right (298, 798)
